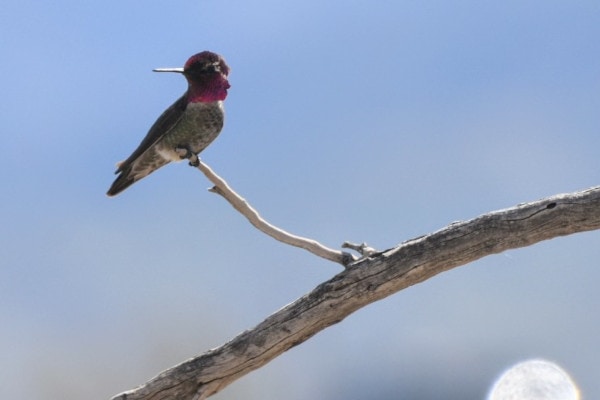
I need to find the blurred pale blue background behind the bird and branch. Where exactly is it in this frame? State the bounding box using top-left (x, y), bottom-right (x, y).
top-left (0, 0), bottom-right (600, 400)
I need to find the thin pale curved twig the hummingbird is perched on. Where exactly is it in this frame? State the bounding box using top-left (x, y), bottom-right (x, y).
top-left (198, 160), bottom-right (356, 267)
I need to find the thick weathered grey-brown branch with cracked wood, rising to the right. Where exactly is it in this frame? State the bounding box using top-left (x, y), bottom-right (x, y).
top-left (114, 187), bottom-right (600, 400)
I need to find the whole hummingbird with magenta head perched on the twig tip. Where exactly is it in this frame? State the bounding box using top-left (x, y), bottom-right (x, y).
top-left (106, 51), bottom-right (230, 196)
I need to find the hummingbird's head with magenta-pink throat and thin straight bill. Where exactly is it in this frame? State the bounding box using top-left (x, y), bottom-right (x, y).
top-left (154, 51), bottom-right (231, 103)
